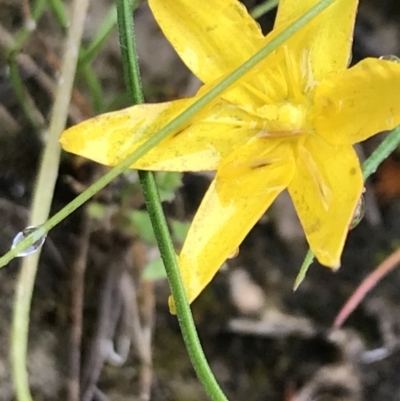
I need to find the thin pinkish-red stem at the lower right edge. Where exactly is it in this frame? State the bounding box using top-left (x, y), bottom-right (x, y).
top-left (333, 249), bottom-right (400, 328)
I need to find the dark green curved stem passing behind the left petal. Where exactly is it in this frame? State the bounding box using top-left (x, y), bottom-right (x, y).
top-left (117, 0), bottom-right (227, 401)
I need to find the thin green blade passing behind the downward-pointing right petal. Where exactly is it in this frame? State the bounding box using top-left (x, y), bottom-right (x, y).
top-left (293, 126), bottom-right (400, 291)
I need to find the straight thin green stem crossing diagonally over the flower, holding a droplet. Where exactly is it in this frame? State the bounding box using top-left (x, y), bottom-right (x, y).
top-left (0, 0), bottom-right (336, 267)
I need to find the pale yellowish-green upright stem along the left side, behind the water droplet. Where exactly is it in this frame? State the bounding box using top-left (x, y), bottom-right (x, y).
top-left (11, 0), bottom-right (88, 401)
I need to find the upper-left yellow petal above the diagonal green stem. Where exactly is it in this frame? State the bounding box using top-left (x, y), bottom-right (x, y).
top-left (149, 0), bottom-right (263, 82)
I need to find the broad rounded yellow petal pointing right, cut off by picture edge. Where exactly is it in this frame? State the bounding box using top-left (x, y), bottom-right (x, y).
top-left (315, 59), bottom-right (400, 143)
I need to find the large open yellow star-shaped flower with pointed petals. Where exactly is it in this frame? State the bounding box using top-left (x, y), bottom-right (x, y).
top-left (61, 0), bottom-right (400, 301)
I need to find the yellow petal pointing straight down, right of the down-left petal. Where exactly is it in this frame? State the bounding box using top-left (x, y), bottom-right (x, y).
top-left (289, 135), bottom-right (363, 268)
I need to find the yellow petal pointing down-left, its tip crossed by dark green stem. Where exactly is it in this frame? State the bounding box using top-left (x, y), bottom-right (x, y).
top-left (170, 138), bottom-right (294, 312)
